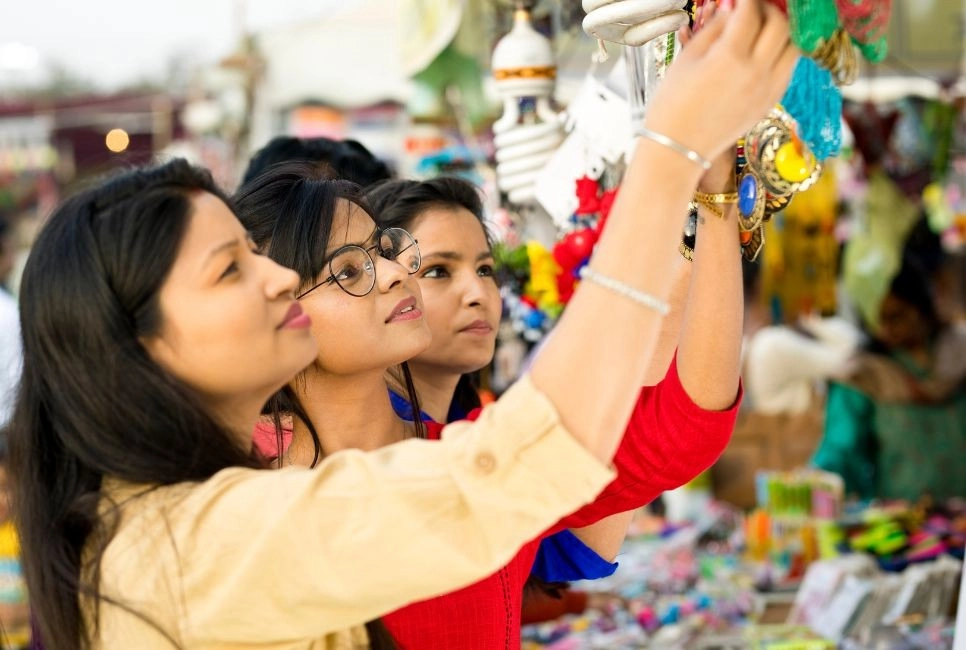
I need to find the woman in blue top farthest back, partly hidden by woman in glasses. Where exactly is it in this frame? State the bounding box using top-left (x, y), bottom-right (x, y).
top-left (366, 176), bottom-right (696, 582)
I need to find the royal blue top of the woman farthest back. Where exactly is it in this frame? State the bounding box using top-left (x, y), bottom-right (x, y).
top-left (389, 390), bottom-right (617, 582)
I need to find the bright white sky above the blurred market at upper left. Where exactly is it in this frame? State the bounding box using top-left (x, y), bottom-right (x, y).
top-left (0, 0), bottom-right (348, 88)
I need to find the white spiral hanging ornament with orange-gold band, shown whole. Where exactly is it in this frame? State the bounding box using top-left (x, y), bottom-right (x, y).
top-left (492, 8), bottom-right (563, 204)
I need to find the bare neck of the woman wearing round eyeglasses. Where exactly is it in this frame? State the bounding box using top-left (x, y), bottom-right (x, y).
top-left (286, 369), bottom-right (411, 466)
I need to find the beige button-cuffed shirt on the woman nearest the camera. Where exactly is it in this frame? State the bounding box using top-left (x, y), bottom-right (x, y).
top-left (93, 377), bottom-right (613, 650)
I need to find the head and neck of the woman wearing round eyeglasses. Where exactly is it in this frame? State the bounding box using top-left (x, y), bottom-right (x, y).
top-left (234, 163), bottom-right (430, 476)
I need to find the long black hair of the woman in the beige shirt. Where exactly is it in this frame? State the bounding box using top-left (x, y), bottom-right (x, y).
top-left (9, 160), bottom-right (260, 650)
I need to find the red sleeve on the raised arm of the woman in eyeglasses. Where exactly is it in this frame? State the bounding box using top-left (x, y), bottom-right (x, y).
top-left (550, 357), bottom-right (742, 532)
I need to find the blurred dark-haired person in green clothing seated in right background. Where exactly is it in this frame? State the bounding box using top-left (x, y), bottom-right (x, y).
top-left (814, 255), bottom-right (966, 501)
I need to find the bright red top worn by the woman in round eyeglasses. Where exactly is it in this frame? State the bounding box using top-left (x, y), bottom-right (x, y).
top-left (382, 360), bottom-right (741, 650)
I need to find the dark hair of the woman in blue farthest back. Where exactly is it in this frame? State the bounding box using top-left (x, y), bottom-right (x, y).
top-left (366, 176), bottom-right (493, 413)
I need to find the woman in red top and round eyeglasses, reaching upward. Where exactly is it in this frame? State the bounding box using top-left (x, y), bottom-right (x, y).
top-left (236, 0), bottom-right (793, 648)
